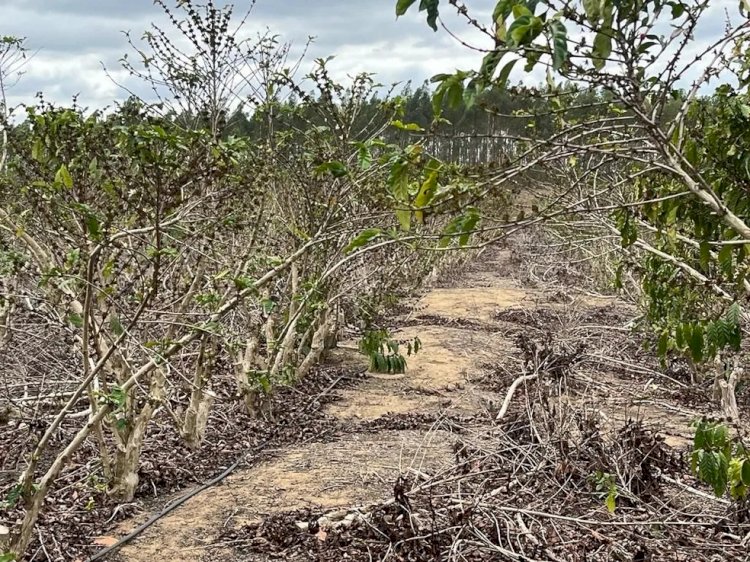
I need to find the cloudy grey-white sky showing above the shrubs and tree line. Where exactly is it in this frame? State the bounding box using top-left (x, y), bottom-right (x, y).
top-left (0, 0), bottom-right (736, 107)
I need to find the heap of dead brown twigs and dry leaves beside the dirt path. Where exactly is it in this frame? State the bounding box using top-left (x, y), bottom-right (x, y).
top-left (223, 330), bottom-right (750, 562)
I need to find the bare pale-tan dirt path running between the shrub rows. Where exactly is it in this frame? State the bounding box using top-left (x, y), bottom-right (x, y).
top-left (113, 250), bottom-right (527, 562)
